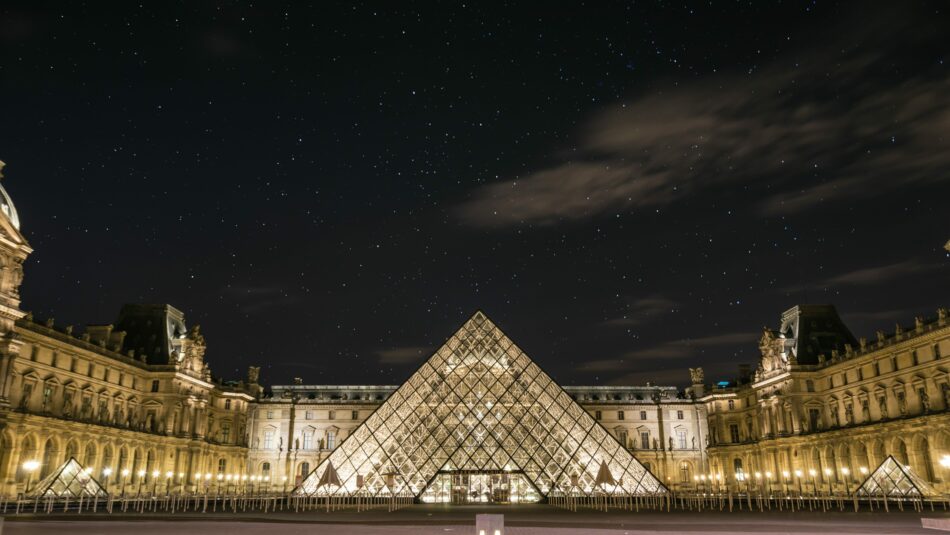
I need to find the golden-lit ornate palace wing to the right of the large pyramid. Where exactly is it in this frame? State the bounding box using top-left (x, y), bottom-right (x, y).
top-left (698, 305), bottom-right (950, 491)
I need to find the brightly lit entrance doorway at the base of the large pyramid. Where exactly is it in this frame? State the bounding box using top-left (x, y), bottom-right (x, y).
top-left (421, 470), bottom-right (541, 505)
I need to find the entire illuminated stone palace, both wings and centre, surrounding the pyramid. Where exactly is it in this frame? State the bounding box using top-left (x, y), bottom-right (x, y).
top-left (0, 171), bottom-right (950, 495)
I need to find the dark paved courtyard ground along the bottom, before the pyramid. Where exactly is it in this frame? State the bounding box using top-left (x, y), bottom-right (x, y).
top-left (3, 505), bottom-right (948, 535)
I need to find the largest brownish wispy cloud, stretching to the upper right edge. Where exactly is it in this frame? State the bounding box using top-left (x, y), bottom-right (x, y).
top-left (457, 10), bottom-right (950, 228)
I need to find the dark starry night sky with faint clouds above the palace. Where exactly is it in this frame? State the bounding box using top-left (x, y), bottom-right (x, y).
top-left (0, 0), bottom-right (950, 392)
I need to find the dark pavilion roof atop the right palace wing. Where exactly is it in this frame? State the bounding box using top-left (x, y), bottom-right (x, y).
top-left (780, 305), bottom-right (858, 365)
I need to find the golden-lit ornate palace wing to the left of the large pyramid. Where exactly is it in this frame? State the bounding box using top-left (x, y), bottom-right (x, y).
top-left (0, 170), bottom-right (260, 495)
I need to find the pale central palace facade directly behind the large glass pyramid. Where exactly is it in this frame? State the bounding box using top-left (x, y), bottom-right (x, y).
top-left (248, 381), bottom-right (708, 490)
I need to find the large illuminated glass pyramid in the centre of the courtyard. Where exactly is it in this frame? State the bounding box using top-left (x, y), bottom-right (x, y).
top-left (294, 312), bottom-right (667, 502)
